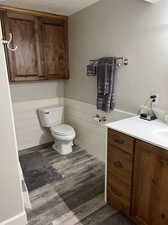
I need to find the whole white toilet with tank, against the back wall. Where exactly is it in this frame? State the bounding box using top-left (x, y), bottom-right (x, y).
top-left (38, 106), bottom-right (75, 155)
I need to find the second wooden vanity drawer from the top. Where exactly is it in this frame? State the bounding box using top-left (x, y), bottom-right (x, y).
top-left (107, 144), bottom-right (133, 184)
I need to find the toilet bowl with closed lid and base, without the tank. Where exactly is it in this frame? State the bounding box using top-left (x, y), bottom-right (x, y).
top-left (50, 124), bottom-right (75, 155)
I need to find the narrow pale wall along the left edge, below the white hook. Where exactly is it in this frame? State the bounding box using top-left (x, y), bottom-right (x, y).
top-left (0, 22), bottom-right (26, 225)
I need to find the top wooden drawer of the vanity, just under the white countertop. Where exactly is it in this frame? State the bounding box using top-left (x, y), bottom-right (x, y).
top-left (108, 128), bottom-right (134, 154)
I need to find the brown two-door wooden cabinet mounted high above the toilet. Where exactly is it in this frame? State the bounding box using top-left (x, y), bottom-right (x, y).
top-left (1, 7), bottom-right (69, 81)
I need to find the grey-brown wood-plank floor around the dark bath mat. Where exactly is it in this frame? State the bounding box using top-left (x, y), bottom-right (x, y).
top-left (21, 147), bottom-right (135, 225)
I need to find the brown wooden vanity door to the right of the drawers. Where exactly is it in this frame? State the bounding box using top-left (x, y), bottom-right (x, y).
top-left (132, 141), bottom-right (168, 225)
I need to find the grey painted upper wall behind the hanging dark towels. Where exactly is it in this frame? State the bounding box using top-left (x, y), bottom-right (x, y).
top-left (65, 0), bottom-right (168, 113)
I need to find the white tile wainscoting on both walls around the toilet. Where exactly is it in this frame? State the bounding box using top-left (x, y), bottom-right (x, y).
top-left (13, 97), bottom-right (134, 155)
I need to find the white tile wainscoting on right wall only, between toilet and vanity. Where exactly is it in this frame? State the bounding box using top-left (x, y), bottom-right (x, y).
top-left (64, 98), bottom-right (135, 161)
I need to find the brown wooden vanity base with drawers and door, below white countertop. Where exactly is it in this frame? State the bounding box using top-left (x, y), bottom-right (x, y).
top-left (107, 121), bottom-right (168, 225)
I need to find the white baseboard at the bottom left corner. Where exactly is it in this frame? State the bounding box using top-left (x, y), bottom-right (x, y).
top-left (0, 212), bottom-right (27, 225)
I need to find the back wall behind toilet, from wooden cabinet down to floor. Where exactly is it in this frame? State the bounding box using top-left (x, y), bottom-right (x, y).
top-left (10, 81), bottom-right (64, 150)
